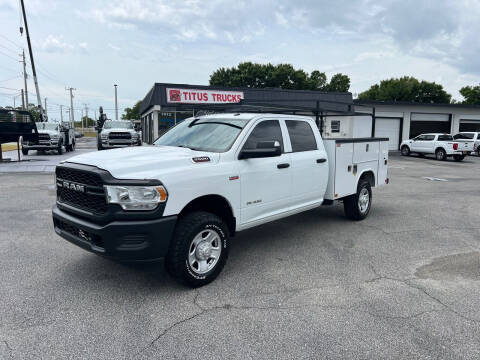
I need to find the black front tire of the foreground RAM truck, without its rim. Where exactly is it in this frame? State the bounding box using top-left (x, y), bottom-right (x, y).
top-left (165, 211), bottom-right (230, 287)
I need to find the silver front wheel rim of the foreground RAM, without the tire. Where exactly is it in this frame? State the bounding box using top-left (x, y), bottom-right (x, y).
top-left (188, 229), bottom-right (222, 274)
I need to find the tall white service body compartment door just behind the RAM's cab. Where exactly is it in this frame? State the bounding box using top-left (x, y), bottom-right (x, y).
top-left (333, 142), bottom-right (356, 199)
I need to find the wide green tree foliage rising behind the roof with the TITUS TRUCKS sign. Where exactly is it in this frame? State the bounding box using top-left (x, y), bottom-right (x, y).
top-left (210, 62), bottom-right (350, 92)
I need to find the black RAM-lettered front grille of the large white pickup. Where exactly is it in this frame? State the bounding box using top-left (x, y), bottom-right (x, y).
top-left (55, 167), bottom-right (107, 214)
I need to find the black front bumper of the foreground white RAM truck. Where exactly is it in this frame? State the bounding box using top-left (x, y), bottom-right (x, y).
top-left (52, 205), bottom-right (177, 261)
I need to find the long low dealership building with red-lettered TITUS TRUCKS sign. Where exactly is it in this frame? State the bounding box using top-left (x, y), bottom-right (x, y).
top-left (140, 83), bottom-right (480, 150)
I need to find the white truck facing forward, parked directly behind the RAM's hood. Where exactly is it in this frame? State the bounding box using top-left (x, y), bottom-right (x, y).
top-left (97, 120), bottom-right (141, 150)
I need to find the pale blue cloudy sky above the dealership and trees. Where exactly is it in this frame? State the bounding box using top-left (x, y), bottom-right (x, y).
top-left (0, 0), bottom-right (480, 119)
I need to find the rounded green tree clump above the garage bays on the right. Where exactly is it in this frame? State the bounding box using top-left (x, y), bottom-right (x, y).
top-left (358, 76), bottom-right (452, 104)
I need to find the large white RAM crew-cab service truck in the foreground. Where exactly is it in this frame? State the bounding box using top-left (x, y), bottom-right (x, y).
top-left (53, 113), bottom-right (389, 286)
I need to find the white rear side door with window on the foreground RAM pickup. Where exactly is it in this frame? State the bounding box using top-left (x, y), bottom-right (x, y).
top-left (285, 119), bottom-right (328, 207)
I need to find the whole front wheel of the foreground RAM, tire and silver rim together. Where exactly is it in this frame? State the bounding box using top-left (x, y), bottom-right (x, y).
top-left (165, 211), bottom-right (229, 287)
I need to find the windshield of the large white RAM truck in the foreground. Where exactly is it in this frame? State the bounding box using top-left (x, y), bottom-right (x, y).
top-left (153, 118), bottom-right (247, 152)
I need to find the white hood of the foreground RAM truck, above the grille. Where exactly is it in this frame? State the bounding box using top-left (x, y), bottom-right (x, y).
top-left (67, 145), bottom-right (220, 180)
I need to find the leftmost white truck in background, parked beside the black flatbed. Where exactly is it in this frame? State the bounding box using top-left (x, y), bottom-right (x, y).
top-left (22, 121), bottom-right (76, 155)
